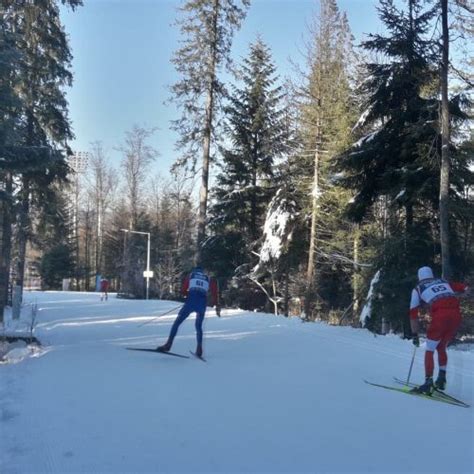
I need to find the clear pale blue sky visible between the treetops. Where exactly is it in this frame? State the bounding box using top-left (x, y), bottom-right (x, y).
top-left (62, 0), bottom-right (382, 175)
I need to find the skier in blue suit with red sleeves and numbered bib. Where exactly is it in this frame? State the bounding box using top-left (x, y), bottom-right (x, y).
top-left (156, 266), bottom-right (220, 357)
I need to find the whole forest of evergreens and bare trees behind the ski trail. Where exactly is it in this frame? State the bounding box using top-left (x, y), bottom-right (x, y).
top-left (0, 0), bottom-right (474, 337)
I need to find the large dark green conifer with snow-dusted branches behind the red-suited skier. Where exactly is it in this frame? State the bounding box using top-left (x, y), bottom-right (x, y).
top-left (340, 0), bottom-right (470, 332)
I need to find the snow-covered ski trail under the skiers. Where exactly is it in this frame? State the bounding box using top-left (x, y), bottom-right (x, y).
top-left (0, 292), bottom-right (474, 474)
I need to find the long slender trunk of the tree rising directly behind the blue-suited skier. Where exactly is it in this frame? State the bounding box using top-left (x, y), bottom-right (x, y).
top-left (196, 0), bottom-right (220, 263)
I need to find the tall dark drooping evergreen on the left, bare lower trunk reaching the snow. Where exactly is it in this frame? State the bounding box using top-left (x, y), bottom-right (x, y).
top-left (3, 0), bottom-right (81, 302)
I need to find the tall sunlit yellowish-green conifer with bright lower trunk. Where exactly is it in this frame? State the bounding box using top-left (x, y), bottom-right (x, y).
top-left (293, 0), bottom-right (355, 318)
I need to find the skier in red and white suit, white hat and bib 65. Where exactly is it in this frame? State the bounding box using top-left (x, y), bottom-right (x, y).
top-left (410, 267), bottom-right (467, 394)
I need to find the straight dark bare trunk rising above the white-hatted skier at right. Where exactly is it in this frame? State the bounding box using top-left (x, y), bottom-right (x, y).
top-left (439, 0), bottom-right (451, 279)
